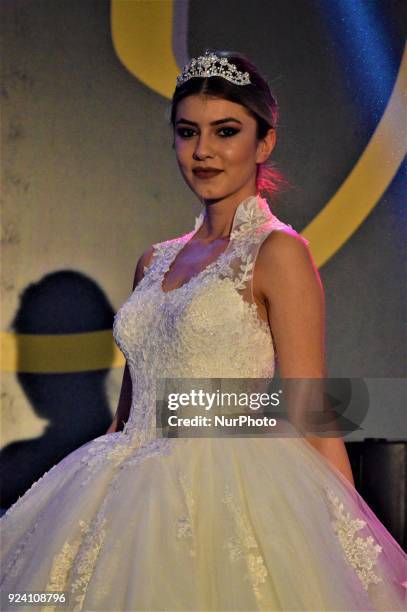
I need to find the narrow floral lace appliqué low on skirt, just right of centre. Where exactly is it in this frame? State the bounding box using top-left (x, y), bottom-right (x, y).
top-left (222, 487), bottom-right (268, 600)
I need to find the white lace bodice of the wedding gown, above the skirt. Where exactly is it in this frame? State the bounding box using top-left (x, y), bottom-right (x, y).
top-left (113, 195), bottom-right (302, 437)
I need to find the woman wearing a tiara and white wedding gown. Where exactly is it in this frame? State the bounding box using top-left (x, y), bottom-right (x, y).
top-left (2, 52), bottom-right (407, 612)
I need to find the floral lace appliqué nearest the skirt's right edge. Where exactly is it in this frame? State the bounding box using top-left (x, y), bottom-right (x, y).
top-left (326, 489), bottom-right (382, 591)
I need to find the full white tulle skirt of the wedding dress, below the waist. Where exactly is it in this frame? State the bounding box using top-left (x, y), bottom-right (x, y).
top-left (0, 432), bottom-right (407, 612)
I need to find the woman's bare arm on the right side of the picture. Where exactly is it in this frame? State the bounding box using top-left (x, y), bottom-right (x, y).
top-left (255, 230), bottom-right (354, 486)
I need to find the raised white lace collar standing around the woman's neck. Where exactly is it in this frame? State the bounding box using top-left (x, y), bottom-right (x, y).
top-left (194, 194), bottom-right (274, 239)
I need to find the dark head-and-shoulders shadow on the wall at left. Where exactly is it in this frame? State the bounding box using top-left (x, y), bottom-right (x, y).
top-left (0, 270), bottom-right (114, 508)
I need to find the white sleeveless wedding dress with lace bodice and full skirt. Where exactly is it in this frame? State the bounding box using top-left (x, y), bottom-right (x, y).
top-left (0, 196), bottom-right (407, 612)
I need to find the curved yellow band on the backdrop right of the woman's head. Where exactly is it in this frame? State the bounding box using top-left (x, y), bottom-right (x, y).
top-left (301, 41), bottom-right (407, 267)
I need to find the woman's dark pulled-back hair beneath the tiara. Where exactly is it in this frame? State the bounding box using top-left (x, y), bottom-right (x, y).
top-left (169, 49), bottom-right (289, 201)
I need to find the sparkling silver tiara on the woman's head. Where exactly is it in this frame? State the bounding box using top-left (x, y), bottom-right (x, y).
top-left (176, 51), bottom-right (251, 87)
